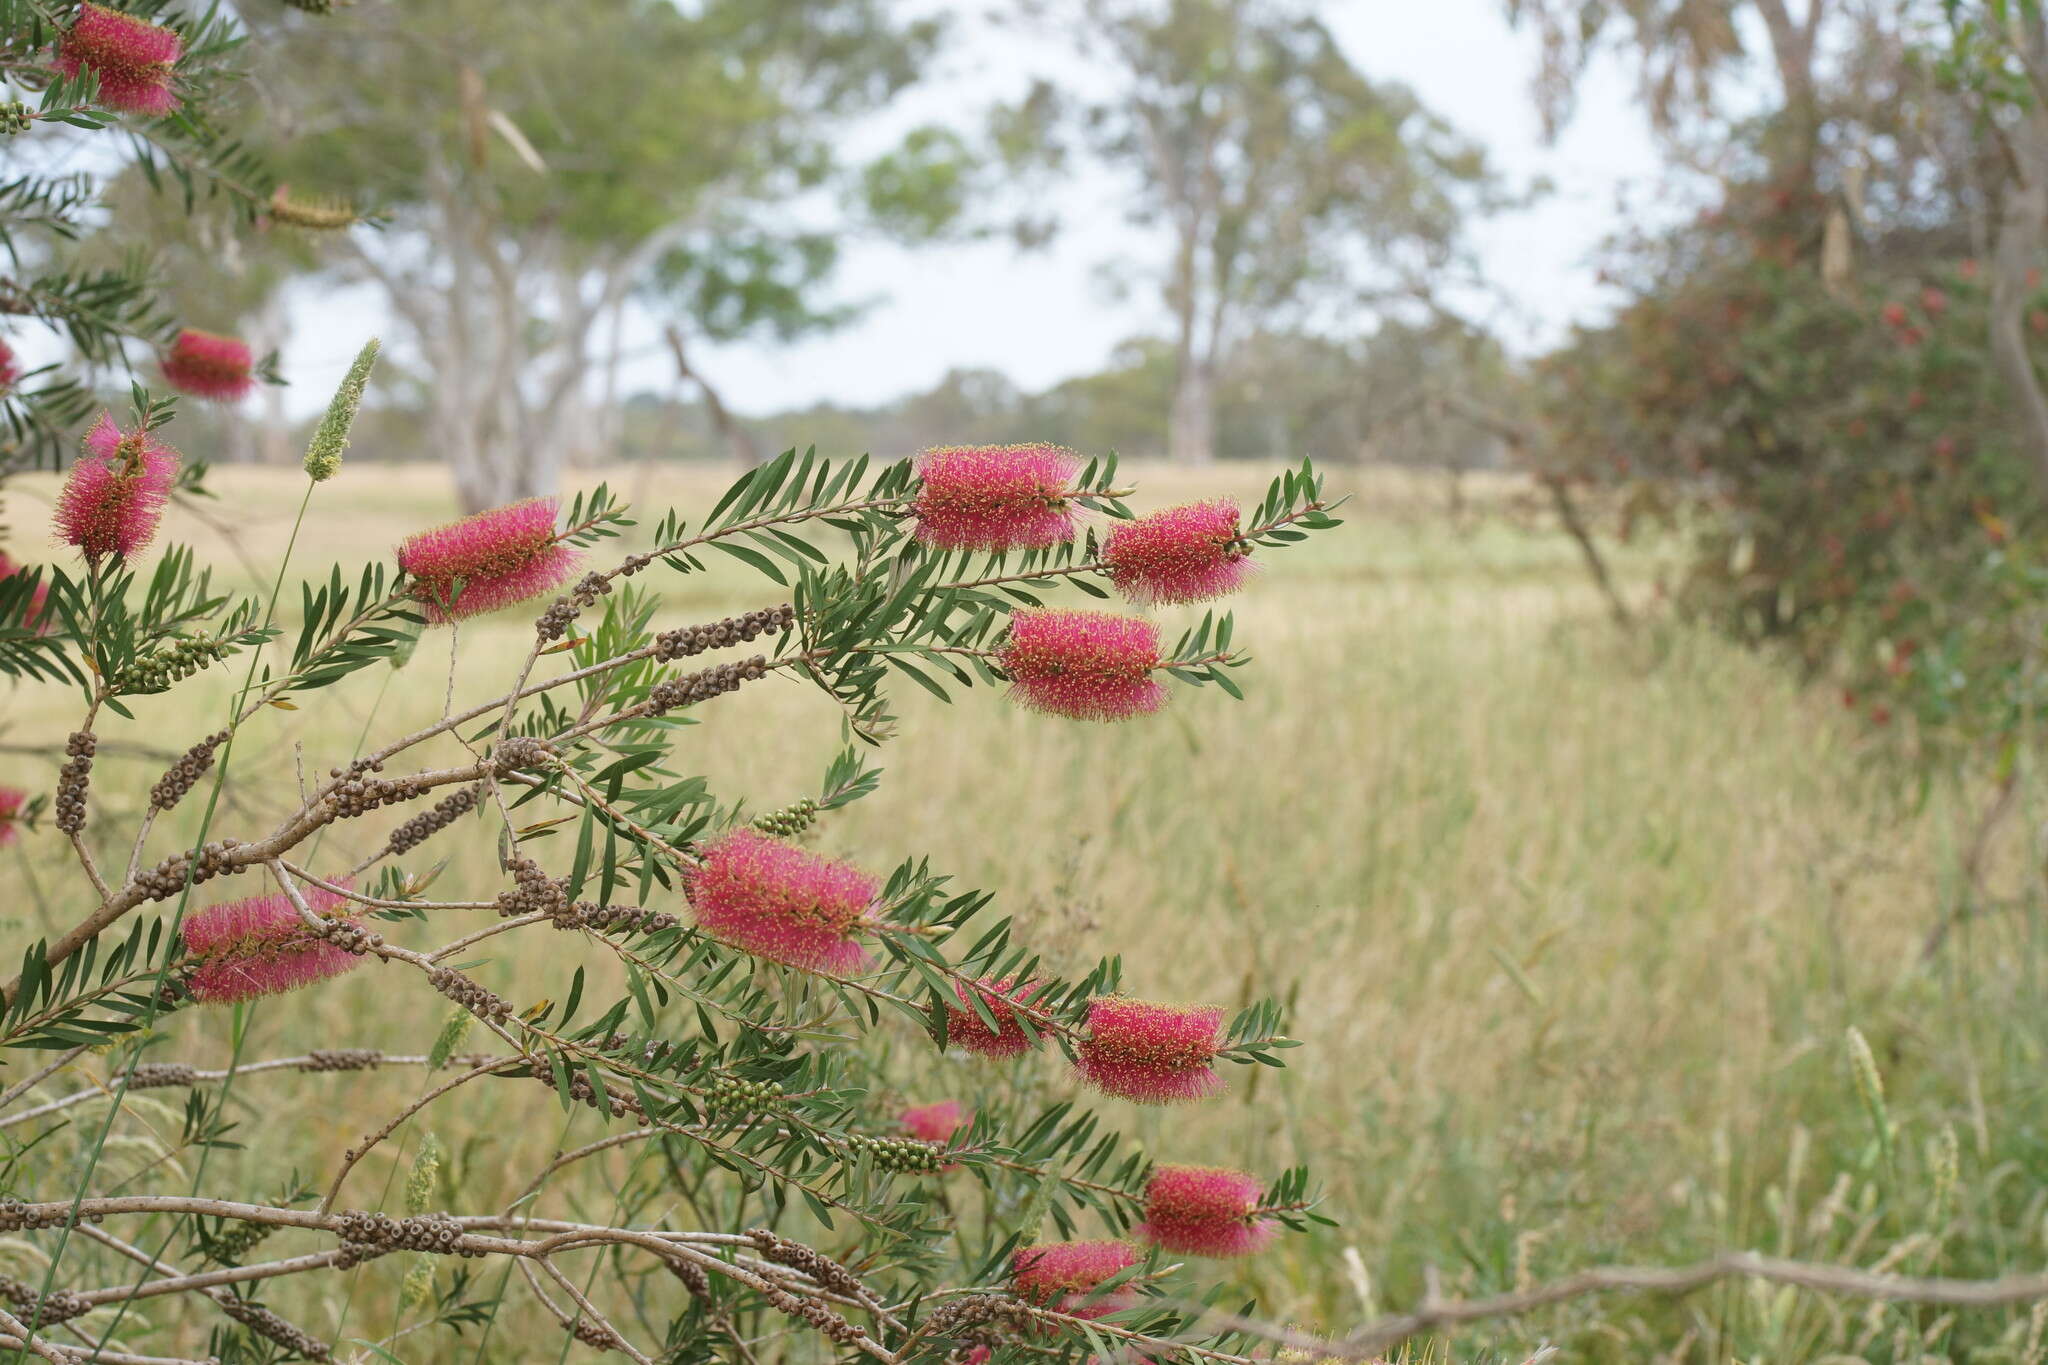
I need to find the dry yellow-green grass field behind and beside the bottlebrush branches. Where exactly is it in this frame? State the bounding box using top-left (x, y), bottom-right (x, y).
top-left (0, 465), bottom-right (2048, 1363)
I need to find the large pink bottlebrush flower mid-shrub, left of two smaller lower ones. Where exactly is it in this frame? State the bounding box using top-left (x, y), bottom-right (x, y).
top-left (684, 827), bottom-right (877, 974)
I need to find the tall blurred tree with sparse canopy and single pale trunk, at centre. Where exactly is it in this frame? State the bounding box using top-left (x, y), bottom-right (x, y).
top-left (1024, 0), bottom-right (1487, 463)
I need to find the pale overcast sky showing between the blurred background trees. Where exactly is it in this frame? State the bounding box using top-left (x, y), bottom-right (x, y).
top-left (285, 0), bottom-right (1657, 413)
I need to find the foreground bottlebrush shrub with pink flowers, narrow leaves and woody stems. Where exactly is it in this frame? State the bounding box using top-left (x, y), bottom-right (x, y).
top-left (0, 368), bottom-right (1337, 1365)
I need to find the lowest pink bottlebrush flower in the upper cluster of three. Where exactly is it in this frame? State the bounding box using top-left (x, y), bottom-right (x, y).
top-left (995, 608), bottom-right (1165, 720)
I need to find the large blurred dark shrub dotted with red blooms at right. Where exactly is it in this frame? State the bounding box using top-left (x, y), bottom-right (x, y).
top-left (1536, 169), bottom-right (2048, 765)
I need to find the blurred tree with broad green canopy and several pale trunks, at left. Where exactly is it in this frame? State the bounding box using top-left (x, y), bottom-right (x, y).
top-left (258, 0), bottom-right (958, 508)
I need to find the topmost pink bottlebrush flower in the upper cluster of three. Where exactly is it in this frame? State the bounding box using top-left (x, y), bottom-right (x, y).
top-left (911, 444), bottom-right (1081, 551)
